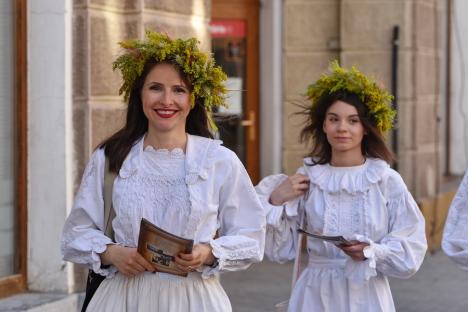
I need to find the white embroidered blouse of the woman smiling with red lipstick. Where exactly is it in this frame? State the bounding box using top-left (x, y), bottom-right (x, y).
top-left (62, 135), bottom-right (265, 277)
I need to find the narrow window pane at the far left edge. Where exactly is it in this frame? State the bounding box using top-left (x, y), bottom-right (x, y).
top-left (0, 1), bottom-right (16, 277)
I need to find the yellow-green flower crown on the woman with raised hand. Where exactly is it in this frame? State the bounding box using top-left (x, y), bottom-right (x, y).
top-left (307, 60), bottom-right (396, 134)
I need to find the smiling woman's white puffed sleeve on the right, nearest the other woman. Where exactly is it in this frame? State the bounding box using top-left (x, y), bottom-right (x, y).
top-left (203, 151), bottom-right (265, 276)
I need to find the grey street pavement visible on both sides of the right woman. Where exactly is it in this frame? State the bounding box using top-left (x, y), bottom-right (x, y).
top-left (221, 252), bottom-right (468, 312)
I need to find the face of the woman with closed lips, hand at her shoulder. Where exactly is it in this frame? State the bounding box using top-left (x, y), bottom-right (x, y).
top-left (323, 101), bottom-right (366, 155)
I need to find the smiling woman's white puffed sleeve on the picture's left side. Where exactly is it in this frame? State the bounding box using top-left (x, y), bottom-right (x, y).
top-left (61, 149), bottom-right (117, 277)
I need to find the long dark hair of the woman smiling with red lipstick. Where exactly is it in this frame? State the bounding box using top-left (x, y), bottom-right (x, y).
top-left (98, 62), bottom-right (213, 173)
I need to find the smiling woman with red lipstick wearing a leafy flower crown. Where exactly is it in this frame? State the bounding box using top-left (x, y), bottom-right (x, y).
top-left (62, 31), bottom-right (265, 312)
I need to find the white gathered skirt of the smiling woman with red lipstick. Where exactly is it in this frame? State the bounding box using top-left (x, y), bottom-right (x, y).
top-left (86, 272), bottom-right (232, 312)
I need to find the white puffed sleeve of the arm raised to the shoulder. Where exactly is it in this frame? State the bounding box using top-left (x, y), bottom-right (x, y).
top-left (255, 167), bottom-right (305, 263)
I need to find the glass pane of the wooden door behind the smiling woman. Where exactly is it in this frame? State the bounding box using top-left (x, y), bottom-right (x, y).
top-left (210, 20), bottom-right (246, 165)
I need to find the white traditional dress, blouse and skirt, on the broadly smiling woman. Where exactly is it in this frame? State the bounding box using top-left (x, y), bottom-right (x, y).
top-left (62, 135), bottom-right (265, 312)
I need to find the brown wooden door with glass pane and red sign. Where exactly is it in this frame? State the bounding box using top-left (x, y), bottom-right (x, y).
top-left (210, 0), bottom-right (260, 183)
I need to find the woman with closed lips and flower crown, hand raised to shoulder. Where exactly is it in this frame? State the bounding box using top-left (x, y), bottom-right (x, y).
top-left (256, 62), bottom-right (427, 312)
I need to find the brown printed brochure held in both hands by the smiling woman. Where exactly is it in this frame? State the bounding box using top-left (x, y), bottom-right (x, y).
top-left (138, 218), bottom-right (193, 276)
